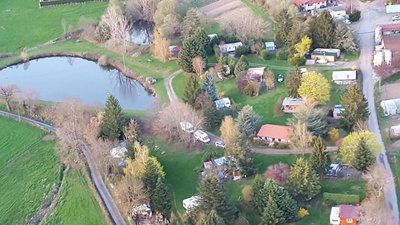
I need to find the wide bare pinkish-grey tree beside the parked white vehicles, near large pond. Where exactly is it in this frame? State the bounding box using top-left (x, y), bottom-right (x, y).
top-left (153, 102), bottom-right (203, 144)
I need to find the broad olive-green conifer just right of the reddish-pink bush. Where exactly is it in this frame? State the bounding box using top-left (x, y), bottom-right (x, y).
top-left (286, 158), bottom-right (321, 200)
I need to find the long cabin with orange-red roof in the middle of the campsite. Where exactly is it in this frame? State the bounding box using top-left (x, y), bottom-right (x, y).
top-left (257, 124), bottom-right (292, 143)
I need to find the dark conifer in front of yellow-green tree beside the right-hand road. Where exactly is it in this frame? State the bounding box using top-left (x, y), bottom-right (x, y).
top-left (353, 138), bottom-right (375, 173)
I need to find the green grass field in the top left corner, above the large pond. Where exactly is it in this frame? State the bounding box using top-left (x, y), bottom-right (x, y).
top-left (0, 0), bottom-right (107, 53)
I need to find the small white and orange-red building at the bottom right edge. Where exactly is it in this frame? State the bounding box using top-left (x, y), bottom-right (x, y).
top-left (329, 205), bottom-right (360, 225)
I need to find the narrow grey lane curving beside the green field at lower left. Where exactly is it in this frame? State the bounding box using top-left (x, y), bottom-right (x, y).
top-left (0, 111), bottom-right (126, 225)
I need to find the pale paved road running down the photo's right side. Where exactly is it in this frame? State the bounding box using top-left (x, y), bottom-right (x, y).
top-left (356, 0), bottom-right (399, 224)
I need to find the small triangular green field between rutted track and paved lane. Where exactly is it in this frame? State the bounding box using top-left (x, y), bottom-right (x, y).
top-left (43, 169), bottom-right (106, 225)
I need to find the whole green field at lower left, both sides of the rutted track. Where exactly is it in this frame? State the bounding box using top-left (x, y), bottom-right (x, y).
top-left (0, 117), bottom-right (105, 225)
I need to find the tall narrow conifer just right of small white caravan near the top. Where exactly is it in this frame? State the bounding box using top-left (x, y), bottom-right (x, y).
top-left (275, 9), bottom-right (293, 45)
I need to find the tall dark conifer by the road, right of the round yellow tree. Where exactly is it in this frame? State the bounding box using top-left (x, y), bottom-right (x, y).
top-left (341, 84), bottom-right (369, 131)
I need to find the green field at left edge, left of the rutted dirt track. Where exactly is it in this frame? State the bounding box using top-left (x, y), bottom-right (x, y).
top-left (0, 117), bottom-right (60, 224)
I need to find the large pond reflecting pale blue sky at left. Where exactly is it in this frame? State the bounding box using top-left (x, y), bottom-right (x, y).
top-left (0, 57), bottom-right (155, 110)
